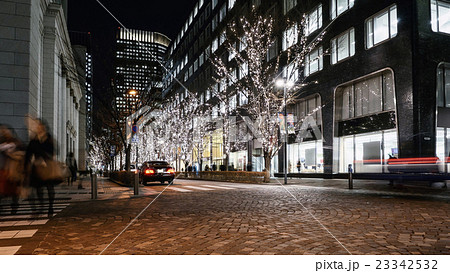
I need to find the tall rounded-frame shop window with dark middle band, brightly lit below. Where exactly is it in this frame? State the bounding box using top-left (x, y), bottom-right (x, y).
top-left (334, 70), bottom-right (398, 173)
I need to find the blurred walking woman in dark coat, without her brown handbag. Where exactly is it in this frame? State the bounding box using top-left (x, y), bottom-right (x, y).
top-left (25, 119), bottom-right (59, 217)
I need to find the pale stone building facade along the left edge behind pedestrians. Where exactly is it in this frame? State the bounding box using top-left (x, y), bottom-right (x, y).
top-left (0, 0), bottom-right (85, 164)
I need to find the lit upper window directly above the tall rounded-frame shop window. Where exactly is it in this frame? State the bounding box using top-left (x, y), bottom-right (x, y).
top-left (366, 5), bottom-right (397, 48)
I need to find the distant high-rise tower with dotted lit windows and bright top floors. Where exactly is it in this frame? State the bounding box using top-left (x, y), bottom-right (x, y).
top-left (114, 28), bottom-right (170, 117)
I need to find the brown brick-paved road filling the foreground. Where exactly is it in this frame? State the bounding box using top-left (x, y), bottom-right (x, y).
top-left (12, 181), bottom-right (450, 254)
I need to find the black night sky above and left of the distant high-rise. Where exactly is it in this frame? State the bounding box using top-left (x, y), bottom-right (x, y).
top-left (68, 0), bottom-right (198, 96)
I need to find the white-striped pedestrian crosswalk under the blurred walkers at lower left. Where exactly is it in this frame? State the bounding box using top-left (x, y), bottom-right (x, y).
top-left (0, 202), bottom-right (70, 255)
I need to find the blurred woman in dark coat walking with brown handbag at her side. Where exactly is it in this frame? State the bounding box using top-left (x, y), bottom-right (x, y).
top-left (25, 118), bottom-right (62, 217)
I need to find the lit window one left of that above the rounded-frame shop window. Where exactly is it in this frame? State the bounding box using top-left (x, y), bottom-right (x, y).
top-left (331, 28), bottom-right (355, 64)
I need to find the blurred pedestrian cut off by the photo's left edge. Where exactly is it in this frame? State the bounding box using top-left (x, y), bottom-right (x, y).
top-left (0, 125), bottom-right (24, 214)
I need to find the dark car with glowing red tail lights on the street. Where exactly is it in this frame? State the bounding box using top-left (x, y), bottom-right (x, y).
top-left (139, 161), bottom-right (175, 185)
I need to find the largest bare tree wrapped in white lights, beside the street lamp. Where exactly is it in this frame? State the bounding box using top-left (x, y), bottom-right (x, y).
top-left (210, 10), bottom-right (324, 180)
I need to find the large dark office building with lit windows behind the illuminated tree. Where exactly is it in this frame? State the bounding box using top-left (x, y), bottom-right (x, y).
top-left (163, 0), bottom-right (450, 175)
